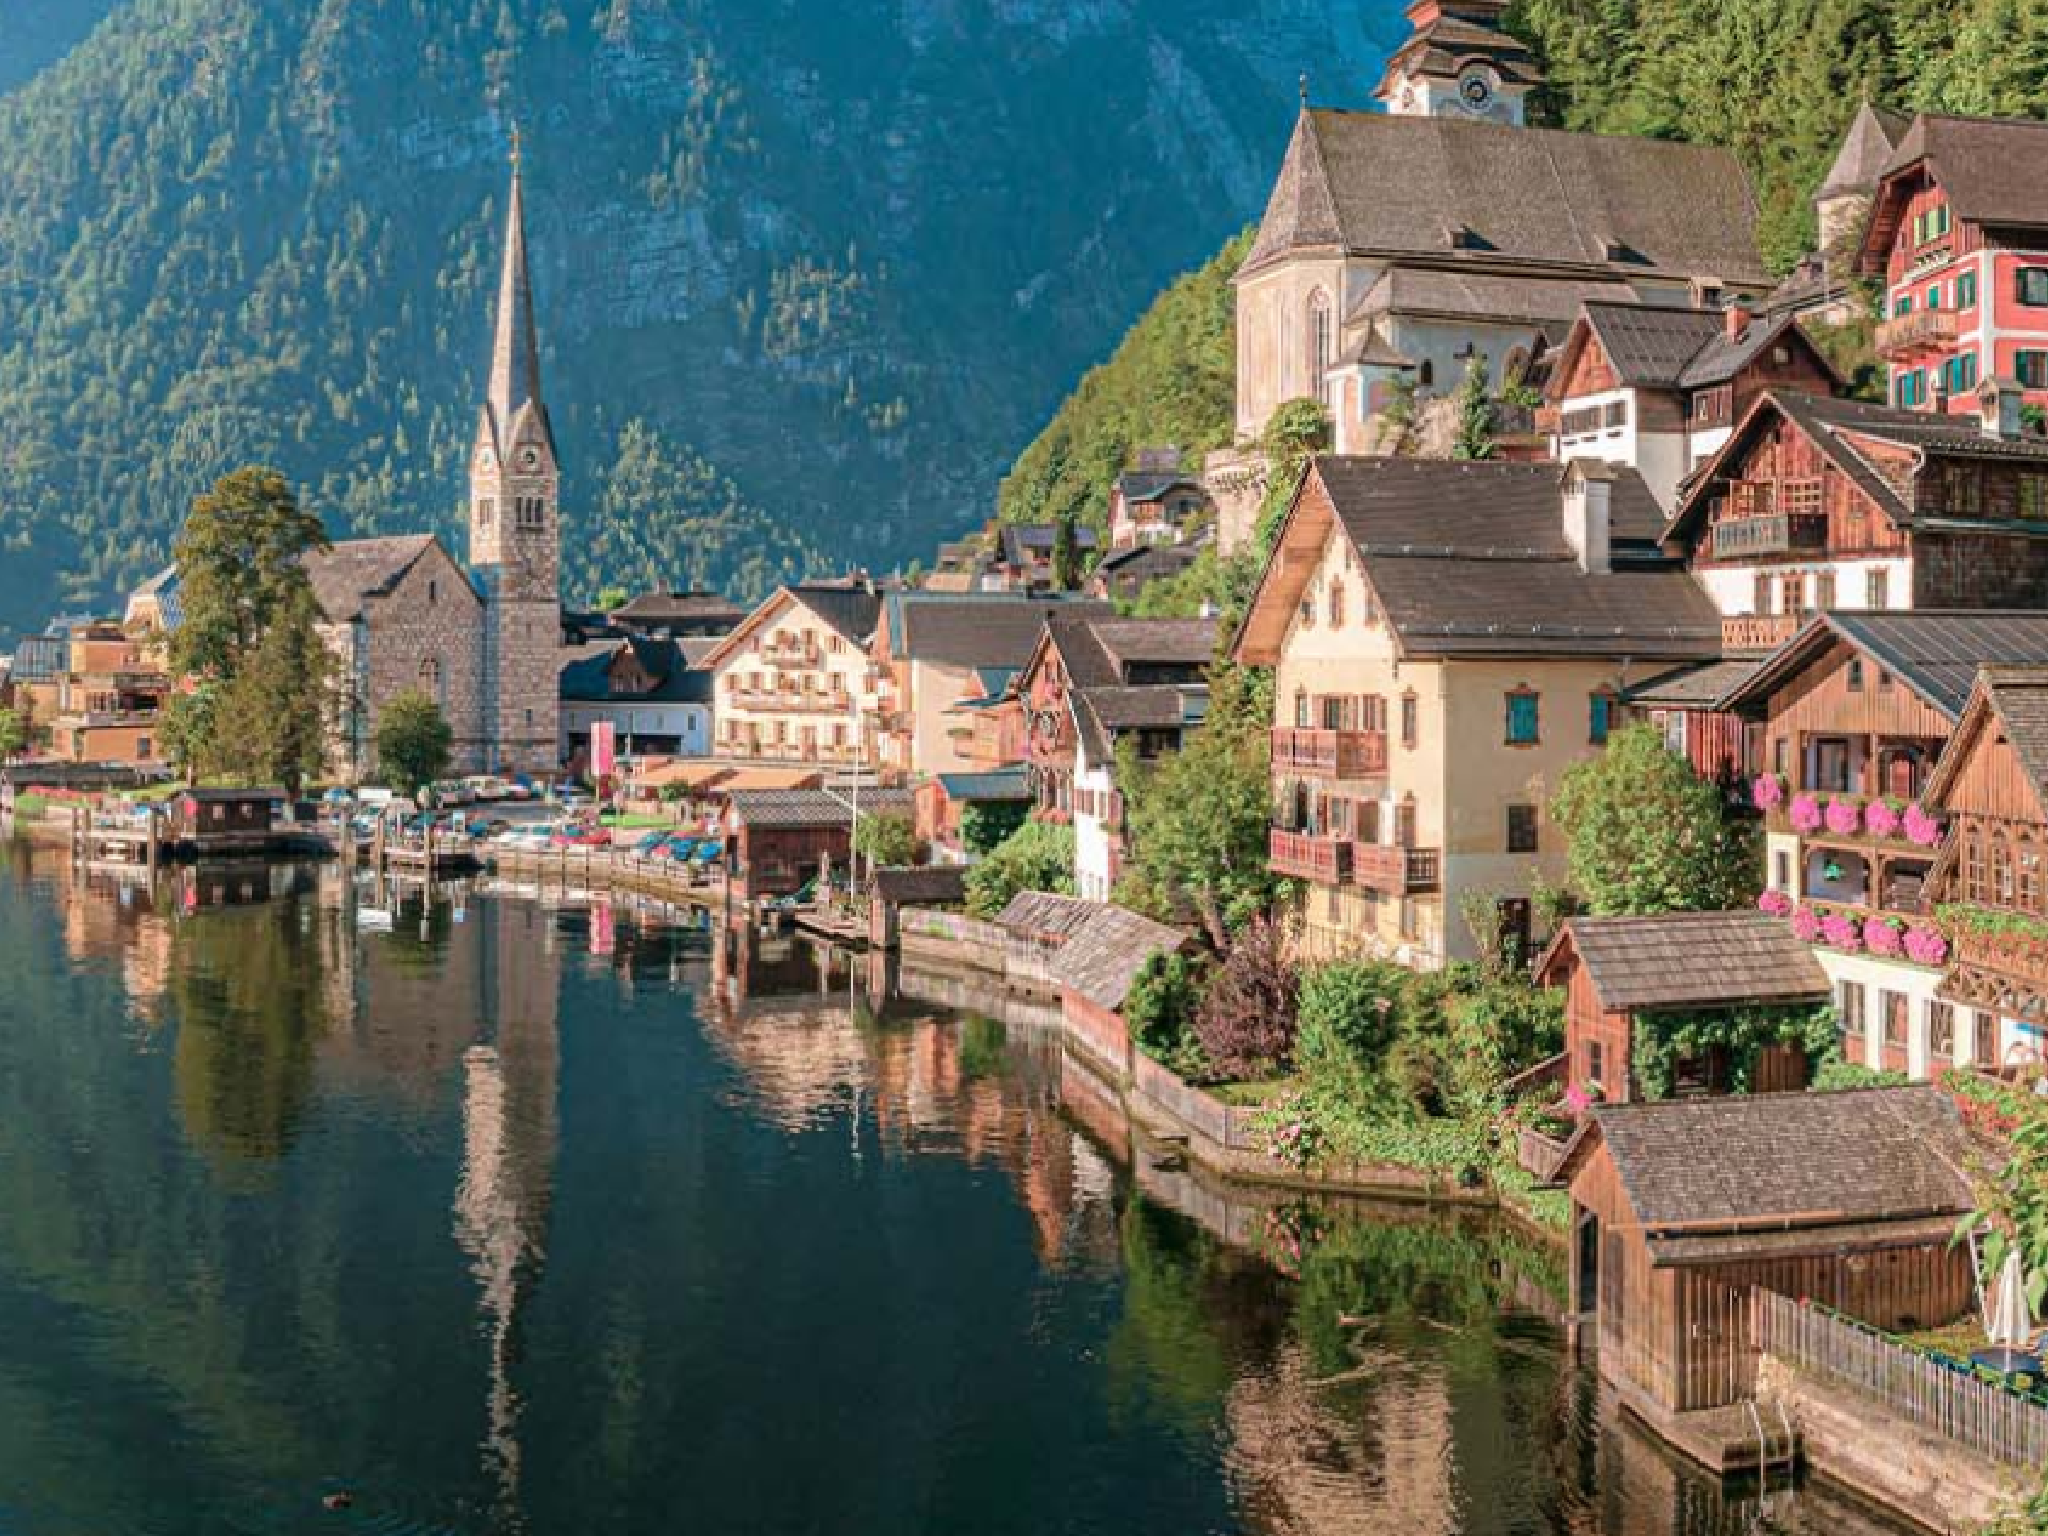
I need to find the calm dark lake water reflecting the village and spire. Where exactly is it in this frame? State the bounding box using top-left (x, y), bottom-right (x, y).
top-left (0, 846), bottom-right (1916, 1536)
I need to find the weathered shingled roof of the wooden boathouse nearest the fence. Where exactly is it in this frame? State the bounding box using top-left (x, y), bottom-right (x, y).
top-left (1561, 1083), bottom-right (1976, 1266)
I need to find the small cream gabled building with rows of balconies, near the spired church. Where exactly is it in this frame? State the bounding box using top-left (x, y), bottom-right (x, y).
top-left (700, 582), bottom-right (881, 768)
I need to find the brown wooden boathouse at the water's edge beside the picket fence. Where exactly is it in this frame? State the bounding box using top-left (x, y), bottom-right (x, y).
top-left (1559, 1085), bottom-right (1974, 1468)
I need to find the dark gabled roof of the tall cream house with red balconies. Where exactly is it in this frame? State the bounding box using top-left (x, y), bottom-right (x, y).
top-left (1239, 455), bottom-right (1720, 664)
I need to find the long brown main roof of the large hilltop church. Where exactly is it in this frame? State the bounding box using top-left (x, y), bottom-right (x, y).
top-left (1239, 109), bottom-right (1769, 289)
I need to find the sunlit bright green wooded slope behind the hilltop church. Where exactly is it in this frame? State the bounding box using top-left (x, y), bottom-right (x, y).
top-left (1001, 0), bottom-right (2048, 536)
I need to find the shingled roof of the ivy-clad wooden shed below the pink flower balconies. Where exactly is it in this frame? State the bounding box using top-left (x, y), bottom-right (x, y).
top-left (1538, 911), bottom-right (1829, 1014)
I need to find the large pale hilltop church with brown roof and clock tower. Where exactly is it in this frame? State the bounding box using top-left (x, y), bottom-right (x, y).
top-left (1237, 0), bottom-right (1772, 453)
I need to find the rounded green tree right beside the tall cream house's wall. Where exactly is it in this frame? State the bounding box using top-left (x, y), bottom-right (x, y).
top-left (1550, 725), bottom-right (1763, 918)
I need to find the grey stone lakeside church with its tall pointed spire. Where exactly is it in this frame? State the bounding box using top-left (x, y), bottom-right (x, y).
top-left (307, 150), bottom-right (561, 780)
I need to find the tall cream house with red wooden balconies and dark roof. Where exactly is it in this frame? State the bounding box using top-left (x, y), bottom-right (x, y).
top-left (1237, 455), bottom-right (1720, 969)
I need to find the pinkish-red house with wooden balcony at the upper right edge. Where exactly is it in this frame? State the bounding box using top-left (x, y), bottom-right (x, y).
top-left (1858, 115), bottom-right (2048, 412)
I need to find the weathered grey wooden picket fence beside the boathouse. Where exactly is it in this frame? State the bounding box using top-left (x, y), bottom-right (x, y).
top-left (1755, 1288), bottom-right (2048, 1468)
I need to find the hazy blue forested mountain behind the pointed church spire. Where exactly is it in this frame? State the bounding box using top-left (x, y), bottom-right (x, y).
top-left (0, 0), bottom-right (1405, 627)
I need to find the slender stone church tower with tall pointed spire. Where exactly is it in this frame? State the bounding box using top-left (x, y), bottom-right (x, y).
top-left (469, 137), bottom-right (561, 772)
